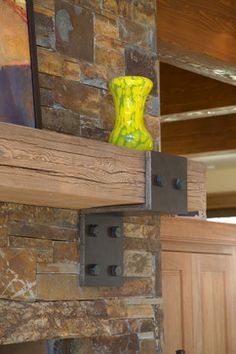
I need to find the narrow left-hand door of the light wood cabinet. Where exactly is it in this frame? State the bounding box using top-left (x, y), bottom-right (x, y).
top-left (162, 252), bottom-right (194, 354)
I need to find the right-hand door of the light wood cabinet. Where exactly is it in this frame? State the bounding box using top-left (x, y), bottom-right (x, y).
top-left (192, 254), bottom-right (236, 354)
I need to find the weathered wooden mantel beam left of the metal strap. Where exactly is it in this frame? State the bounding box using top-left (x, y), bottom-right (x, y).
top-left (0, 123), bottom-right (144, 209)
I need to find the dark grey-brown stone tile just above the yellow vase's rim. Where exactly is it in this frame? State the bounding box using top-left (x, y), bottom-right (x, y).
top-left (125, 47), bottom-right (157, 95)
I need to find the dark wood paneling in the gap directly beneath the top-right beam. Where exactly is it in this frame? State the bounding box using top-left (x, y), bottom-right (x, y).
top-left (160, 63), bottom-right (236, 115)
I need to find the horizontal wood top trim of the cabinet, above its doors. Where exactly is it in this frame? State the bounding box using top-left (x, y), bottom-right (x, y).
top-left (160, 216), bottom-right (236, 246)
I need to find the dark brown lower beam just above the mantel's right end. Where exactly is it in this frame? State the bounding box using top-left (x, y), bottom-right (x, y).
top-left (161, 114), bottom-right (236, 155)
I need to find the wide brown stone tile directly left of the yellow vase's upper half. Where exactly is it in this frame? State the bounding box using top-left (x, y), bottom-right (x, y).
top-left (54, 78), bottom-right (100, 116)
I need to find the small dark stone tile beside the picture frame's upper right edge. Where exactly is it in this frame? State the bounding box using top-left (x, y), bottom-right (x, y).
top-left (34, 12), bottom-right (56, 49)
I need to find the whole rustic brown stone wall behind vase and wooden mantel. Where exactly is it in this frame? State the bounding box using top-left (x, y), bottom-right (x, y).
top-left (0, 0), bottom-right (162, 354)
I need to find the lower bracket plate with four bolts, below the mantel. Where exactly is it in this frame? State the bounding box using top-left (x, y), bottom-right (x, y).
top-left (80, 214), bottom-right (123, 287)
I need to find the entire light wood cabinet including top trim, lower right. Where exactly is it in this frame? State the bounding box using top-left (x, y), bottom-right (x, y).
top-left (161, 218), bottom-right (236, 354)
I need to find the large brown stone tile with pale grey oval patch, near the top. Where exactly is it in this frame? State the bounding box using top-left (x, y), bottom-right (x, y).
top-left (55, 0), bottom-right (94, 62)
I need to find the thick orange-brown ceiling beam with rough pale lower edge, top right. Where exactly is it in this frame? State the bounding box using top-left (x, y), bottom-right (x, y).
top-left (157, 0), bottom-right (236, 85)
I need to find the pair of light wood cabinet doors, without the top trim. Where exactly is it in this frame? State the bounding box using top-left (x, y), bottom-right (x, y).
top-left (162, 252), bottom-right (236, 354)
